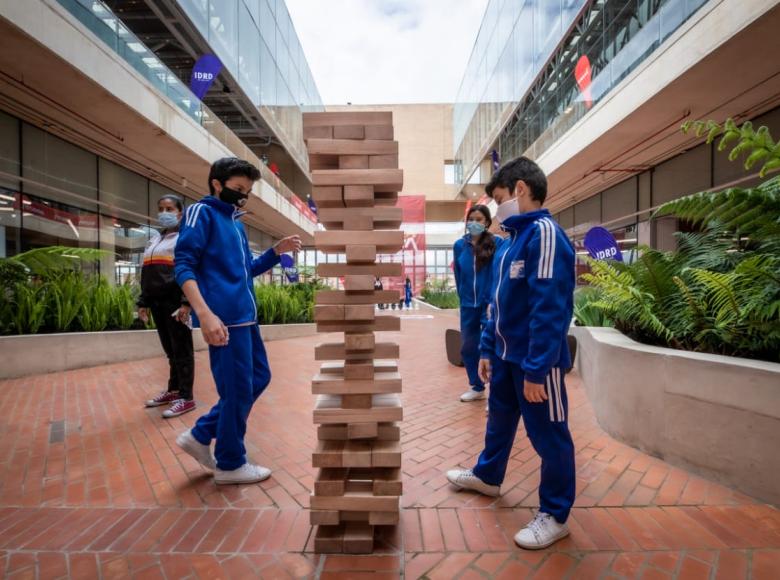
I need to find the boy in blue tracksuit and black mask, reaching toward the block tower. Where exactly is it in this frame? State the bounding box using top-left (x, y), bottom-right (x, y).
top-left (174, 157), bottom-right (301, 484)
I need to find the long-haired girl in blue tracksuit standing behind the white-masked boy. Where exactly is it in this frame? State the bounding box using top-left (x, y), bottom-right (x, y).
top-left (453, 204), bottom-right (497, 403)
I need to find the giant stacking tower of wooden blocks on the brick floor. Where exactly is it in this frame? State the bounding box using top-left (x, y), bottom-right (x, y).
top-left (303, 112), bottom-right (403, 554)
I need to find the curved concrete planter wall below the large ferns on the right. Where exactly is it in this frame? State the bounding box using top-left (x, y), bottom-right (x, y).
top-left (570, 327), bottom-right (780, 505)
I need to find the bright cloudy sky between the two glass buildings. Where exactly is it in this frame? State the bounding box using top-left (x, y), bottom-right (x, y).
top-left (287, 0), bottom-right (488, 105)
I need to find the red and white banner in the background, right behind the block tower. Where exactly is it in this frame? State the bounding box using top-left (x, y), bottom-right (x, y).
top-left (381, 195), bottom-right (425, 299)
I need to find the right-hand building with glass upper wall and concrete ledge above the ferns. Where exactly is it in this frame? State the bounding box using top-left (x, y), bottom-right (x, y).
top-left (453, 0), bottom-right (780, 251)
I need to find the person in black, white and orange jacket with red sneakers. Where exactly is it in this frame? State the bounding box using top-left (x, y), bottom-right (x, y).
top-left (138, 195), bottom-right (196, 418)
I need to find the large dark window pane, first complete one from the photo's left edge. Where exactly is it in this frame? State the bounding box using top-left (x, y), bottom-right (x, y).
top-left (22, 123), bottom-right (97, 211)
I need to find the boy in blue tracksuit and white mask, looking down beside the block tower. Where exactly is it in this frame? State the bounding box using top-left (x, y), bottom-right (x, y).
top-left (447, 157), bottom-right (575, 549)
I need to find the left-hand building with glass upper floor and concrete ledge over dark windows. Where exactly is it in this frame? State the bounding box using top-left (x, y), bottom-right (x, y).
top-left (0, 0), bottom-right (322, 283)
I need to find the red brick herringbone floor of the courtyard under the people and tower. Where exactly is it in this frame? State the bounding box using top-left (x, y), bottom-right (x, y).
top-left (0, 316), bottom-right (780, 580)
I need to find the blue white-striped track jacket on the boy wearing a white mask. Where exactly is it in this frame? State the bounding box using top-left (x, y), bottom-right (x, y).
top-left (480, 209), bottom-right (574, 384)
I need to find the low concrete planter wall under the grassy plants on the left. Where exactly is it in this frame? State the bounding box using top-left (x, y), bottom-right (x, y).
top-left (0, 324), bottom-right (317, 379)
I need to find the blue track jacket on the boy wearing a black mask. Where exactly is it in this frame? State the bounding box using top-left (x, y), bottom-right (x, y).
top-left (174, 196), bottom-right (280, 326)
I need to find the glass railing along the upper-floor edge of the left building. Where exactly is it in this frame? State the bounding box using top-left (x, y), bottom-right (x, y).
top-left (58, 0), bottom-right (312, 230)
